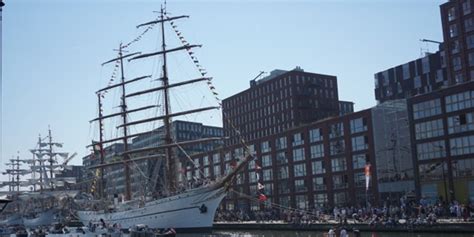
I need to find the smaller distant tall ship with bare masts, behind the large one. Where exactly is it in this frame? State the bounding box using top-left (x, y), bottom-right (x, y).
top-left (0, 129), bottom-right (77, 227)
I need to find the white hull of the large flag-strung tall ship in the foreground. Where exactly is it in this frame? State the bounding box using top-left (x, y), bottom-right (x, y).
top-left (77, 187), bottom-right (226, 229)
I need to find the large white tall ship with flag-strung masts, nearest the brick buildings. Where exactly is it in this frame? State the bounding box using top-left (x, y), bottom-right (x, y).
top-left (77, 4), bottom-right (252, 230)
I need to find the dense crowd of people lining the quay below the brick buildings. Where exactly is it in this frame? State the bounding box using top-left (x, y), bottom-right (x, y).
top-left (216, 196), bottom-right (474, 227)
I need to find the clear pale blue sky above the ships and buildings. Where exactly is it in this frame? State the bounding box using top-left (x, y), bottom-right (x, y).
top-left (0, 0), bottom-right (445, 180)
